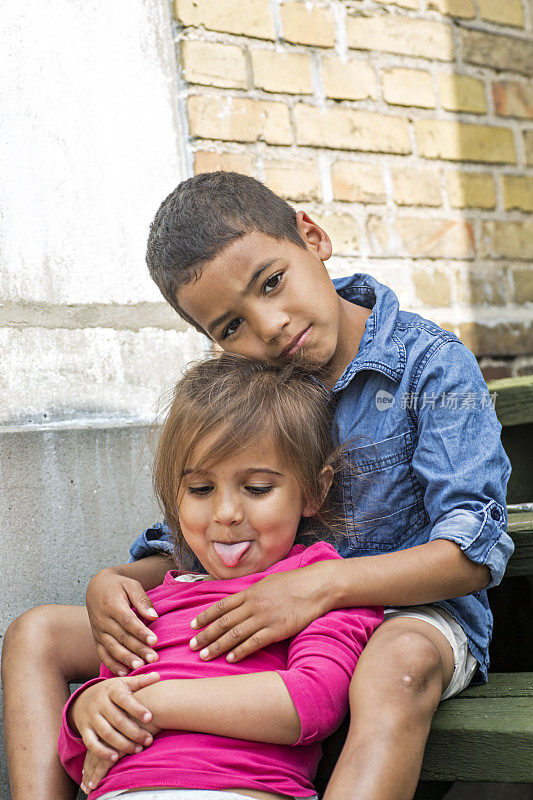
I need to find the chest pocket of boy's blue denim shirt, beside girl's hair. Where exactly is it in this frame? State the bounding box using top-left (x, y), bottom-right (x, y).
top-left (342, 431), bottom-right (428, 554)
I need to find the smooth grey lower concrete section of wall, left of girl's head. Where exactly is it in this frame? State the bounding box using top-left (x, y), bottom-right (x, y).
top-left (0, 422), bottom-right (160, 800)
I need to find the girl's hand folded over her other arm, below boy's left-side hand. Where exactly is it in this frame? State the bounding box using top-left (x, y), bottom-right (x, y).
top-left (68, 672), bottom-right (159, 766)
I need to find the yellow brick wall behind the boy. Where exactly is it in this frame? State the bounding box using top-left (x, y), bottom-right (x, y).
top-left (173, 0), bottom-right (533, 377)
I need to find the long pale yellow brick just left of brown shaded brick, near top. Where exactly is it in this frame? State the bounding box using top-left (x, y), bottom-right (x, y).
top-left (346, 14), bottom-right (454, 61)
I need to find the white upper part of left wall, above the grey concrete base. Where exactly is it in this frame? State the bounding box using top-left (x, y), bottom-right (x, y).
top-left (0, 0), bottom-right (204, 424)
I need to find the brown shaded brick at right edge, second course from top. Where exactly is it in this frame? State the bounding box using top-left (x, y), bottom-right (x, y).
top-left (459, 29), bottom-right (533, 75)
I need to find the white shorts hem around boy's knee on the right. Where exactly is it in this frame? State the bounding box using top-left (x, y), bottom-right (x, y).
top-left (384, 605), bottom-right (478, 700)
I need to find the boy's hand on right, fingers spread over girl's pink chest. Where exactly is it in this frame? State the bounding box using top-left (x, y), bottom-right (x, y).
top-left (190, 562), bottom-right (331, 662)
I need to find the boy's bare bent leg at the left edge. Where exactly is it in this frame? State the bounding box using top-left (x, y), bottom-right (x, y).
top-left (2, 605), bottom-right (99, 800)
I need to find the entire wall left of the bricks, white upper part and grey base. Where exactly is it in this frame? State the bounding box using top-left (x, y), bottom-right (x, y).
top-left (0, 0), bottom-right (204, 798)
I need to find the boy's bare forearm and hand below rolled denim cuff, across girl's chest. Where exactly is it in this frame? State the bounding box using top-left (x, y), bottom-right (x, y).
top-left (191, 539), bottom-right (490, 661)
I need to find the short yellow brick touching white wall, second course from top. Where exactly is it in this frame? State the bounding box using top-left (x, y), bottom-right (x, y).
top-left (181, 41), bottom-right (248, 89)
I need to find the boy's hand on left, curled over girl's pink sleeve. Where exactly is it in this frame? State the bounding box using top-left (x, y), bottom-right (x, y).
top-left (86, 568), bottom-right (159, 677)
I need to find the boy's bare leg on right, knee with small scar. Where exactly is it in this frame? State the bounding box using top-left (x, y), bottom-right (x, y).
top-left (324, 617), bottom-right (454, 800)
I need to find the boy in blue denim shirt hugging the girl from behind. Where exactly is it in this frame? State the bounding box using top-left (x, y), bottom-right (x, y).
top-left (4, 173), bottom-right (512, 800)
